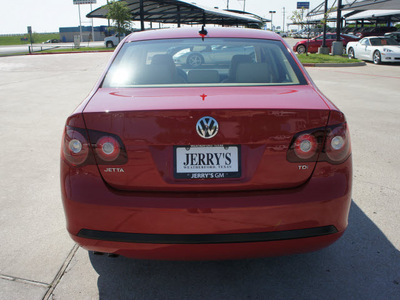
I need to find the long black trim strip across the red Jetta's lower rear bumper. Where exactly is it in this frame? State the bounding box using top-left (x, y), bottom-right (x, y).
top-left (78, 225), bottom-right (338, 244)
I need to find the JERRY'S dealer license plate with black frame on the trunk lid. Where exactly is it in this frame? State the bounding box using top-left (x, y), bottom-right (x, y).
top-left (174, 145), bottom-right (241, 179)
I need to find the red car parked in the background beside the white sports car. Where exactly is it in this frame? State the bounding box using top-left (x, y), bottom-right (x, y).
top-left (293, 33), bottom-right (360, 54)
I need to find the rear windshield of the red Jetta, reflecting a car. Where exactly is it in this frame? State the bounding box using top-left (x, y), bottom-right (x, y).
top-left (103, 38), bottom-right (306, 87)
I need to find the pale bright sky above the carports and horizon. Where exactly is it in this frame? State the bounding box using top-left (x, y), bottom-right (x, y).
top-left (0, 0), bottom-right (323, 34)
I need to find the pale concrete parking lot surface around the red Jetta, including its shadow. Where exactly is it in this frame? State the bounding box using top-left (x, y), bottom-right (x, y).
top-left (0, 53), bottom-right (400, 299)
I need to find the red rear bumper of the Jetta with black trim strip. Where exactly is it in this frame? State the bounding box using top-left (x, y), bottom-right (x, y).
top-left (61, 158), bottom-right (352, 260)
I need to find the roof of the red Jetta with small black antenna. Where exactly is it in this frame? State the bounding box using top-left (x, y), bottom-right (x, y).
top-left (125, 27), bottom-right (282, 42)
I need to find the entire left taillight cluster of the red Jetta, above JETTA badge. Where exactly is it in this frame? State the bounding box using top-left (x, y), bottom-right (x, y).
top-left (62, 126), bottom-right (128, 166)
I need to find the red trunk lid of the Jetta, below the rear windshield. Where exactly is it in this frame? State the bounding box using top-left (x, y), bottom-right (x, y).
top-left (84, 86), bottom-right (329, 191)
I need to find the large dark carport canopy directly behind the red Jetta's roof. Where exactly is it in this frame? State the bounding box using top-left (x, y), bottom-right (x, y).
top-left (86, 0), bottom-right (268, 30)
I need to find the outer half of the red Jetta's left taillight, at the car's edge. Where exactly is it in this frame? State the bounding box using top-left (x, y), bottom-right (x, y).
top-left (62, 126), bottom-right (89, 166)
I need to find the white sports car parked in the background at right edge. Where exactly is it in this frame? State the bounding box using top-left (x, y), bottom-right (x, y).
top-left (346, 36), bottom-right (400, 64)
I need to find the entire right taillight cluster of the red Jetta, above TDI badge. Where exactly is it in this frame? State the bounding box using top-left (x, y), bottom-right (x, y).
top-left (287, 122), bottom-right (351, 164)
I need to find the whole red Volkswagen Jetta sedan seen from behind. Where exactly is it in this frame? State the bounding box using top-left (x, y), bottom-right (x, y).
top-left (61, 28), bottom-right (352, 260)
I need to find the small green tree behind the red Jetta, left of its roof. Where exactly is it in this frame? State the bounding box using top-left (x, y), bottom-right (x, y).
top-left (107, 0), bottom-right (132, 41)
